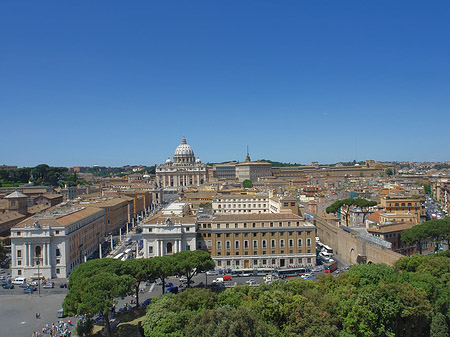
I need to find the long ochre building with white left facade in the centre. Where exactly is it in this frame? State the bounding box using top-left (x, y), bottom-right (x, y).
top-left (142, 201), bottom-right (316, 269)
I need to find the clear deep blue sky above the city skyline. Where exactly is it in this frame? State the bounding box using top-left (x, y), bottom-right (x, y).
top-left (0, 0), bottom-right (450, 166)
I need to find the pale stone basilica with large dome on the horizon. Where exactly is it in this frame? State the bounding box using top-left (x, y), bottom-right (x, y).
top-left (156, 136), bottom-right (208, 189)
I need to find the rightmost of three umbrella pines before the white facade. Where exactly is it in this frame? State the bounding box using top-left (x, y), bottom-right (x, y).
top-left (172, 250), bottom-right (215, 288)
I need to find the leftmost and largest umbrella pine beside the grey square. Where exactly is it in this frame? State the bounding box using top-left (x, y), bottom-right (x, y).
top-left (63, 272), bottom-right (135, 337)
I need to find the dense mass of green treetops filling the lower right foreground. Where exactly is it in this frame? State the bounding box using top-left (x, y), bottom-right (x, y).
top-left (143, 253), bottom-right (450, 337)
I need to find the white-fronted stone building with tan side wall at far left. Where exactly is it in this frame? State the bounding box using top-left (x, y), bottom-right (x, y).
top-left (11, 206), bottom-right (105, 279)
